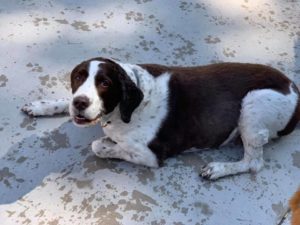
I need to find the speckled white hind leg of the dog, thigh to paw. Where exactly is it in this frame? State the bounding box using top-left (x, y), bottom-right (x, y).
top-left (201, 87), bottom-right (298, 179)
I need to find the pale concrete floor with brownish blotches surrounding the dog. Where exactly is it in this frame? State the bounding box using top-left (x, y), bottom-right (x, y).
top-left (0, 0), bottom-right (300, 225)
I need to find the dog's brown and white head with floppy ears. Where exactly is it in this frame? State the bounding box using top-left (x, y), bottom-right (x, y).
top-left (69, 58), bottom-right (143, 126)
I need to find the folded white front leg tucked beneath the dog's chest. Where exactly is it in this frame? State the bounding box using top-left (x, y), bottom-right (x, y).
top-left (92, 137), bottom-right (158, 167)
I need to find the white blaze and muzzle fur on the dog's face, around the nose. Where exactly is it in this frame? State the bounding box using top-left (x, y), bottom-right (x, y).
top-left (69, 61), bottom-right (103, 126)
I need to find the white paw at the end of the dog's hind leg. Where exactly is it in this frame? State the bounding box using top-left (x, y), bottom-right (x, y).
top-left (200, 162), bottom-right (226, 180)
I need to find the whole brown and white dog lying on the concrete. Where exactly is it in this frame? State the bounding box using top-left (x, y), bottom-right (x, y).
top-left (22, 58), bottom-right (300, 179)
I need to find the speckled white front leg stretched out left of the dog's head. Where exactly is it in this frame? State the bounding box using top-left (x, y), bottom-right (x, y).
top-left (21, 99), bottom-right (69, 116)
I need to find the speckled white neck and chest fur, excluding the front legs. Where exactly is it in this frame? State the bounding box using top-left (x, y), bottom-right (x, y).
top-left (104, 65), bottom-right (170, 144)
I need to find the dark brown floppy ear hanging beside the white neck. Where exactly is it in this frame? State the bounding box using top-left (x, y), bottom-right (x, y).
top-left (119, 67), bottom-right (144, 123)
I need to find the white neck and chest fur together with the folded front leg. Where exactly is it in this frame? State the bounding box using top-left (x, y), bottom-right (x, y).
top-left (92, 63), bottom-right (170, 167)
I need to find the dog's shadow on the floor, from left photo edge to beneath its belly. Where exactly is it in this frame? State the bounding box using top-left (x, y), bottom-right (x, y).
top-left (0, 113), bottom-right (296, 204)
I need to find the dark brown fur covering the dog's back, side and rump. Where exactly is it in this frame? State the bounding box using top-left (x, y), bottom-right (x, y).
top-left (140, 63), bottom-right (299, 163)
